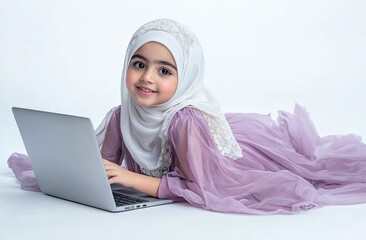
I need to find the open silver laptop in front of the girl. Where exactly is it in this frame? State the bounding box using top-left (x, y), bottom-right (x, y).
top-left (12, 107), bottom-right (173, 212)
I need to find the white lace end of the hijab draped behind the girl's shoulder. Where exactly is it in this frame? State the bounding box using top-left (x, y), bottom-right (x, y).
top-left (202, 112), bottom-right (243, 160)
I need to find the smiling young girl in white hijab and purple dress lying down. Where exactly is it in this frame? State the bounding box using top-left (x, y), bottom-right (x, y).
top-left (9, 19), bottom-right (366, 214)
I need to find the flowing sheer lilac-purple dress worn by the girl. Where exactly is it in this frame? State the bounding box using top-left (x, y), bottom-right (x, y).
top-left (9, 105), bottom-right (366, 214)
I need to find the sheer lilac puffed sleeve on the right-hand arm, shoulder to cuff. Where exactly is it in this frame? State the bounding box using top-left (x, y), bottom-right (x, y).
top-left (158, 108), bottom-right (222, 208)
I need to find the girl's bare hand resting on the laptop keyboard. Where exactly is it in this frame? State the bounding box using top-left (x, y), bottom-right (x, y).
top-left (103, 160), bottom-right (134, 187)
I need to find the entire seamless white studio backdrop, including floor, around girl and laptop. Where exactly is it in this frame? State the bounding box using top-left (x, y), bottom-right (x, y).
top-left (0, 0), bottom-right (366, 239)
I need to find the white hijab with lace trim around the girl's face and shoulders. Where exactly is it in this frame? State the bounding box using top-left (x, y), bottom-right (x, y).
top-left (121, 19), bottom-right (242, 177)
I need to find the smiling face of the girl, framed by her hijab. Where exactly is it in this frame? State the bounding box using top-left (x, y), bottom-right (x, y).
top-left (126, 42), bottom-right (178, 107)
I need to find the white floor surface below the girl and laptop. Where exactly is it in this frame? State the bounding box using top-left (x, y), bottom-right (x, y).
top-left (0, 165), bottom-right (366, 240)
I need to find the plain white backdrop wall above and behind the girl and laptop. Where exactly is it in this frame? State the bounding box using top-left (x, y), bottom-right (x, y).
top-left (0, 0), bottom-right (366, 167)
